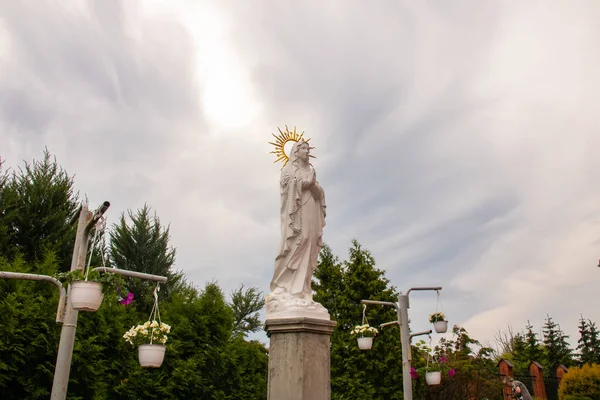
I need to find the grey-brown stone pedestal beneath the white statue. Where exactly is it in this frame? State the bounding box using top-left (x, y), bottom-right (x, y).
top-left (265, 317), bottom-right (336, 400)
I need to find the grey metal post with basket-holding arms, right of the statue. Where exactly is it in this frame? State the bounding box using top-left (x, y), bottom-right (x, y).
top-left (361, 286), bottom-right (442, 400)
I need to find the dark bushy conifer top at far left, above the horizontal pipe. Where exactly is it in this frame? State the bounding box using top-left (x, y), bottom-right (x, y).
top-left (0, 149), bottom-right (78, 271)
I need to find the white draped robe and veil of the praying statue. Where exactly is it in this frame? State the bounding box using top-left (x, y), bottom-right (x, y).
top-left (271, 144), bottom-right (325, 299)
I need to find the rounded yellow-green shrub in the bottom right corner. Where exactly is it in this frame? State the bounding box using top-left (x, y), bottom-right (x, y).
top-left (558, 364), bottom-right (600, 400)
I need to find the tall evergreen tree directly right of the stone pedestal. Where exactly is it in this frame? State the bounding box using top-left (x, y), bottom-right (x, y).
top-left (313, 240), bottom-right (402, 400)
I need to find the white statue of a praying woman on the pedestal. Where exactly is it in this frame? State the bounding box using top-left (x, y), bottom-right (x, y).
top-left (266, 141), bottom-right (329, 319)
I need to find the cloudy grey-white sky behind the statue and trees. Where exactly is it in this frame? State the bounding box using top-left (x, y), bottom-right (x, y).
top-left (0, 0), bottom-right (600, 350)
